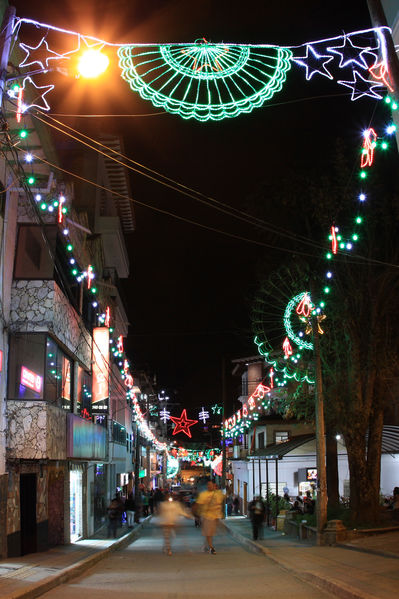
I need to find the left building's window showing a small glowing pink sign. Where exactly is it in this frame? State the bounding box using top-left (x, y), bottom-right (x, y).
top-left (8, 333), bottom-right (46, 400)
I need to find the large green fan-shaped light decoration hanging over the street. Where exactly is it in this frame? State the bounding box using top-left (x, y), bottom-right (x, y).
top-left (118, 40), bottom-right (292, 121)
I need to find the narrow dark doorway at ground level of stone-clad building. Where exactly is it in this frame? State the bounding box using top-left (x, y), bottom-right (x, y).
top-left (19, 474), bottom-right (37, 555)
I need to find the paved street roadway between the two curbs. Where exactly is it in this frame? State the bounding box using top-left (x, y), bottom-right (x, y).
top-left (39, 522), bottom-right (331, 599)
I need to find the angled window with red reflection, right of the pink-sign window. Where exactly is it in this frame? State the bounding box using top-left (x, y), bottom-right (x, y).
top-left (45, 337), bottom-right (73, 412)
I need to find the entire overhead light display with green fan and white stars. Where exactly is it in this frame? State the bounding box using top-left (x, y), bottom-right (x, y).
top-left (7, 18), bottom-right (393, 122)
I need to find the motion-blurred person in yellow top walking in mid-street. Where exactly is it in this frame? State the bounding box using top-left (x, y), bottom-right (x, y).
top-left (194, 480), bottom-right (224, 554)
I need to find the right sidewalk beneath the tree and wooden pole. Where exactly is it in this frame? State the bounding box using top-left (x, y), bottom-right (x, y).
top-left (223, 517), bottom-right (399, 599)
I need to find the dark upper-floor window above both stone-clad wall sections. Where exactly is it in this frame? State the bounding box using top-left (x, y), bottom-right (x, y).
top-left (14, 225), bottom-right (57, 279)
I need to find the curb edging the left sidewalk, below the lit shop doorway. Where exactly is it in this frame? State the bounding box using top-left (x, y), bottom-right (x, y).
top-left (2, 516), bottom-right (151, 599)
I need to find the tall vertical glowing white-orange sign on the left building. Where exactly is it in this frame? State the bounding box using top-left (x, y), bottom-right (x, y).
top-left (92, 327), bottom-right (109, 413)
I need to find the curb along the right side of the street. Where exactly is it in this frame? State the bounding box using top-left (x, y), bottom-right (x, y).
top-left (220, 521), bottom-right (379, 599)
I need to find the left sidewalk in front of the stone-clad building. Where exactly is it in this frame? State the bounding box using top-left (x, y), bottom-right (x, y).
top-left (0, 517), bottom-right (150, 599)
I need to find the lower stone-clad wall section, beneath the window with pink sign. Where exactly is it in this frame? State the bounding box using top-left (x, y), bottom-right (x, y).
top-left (7, 400), bottom-right (66, 460)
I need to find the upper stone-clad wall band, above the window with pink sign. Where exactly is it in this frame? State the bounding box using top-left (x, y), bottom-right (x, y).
top-left (11, 280), bottom-right (91, 368)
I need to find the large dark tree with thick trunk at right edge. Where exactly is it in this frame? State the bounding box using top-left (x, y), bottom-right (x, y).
top-left (253, 136), bottom-right (399, 523)
